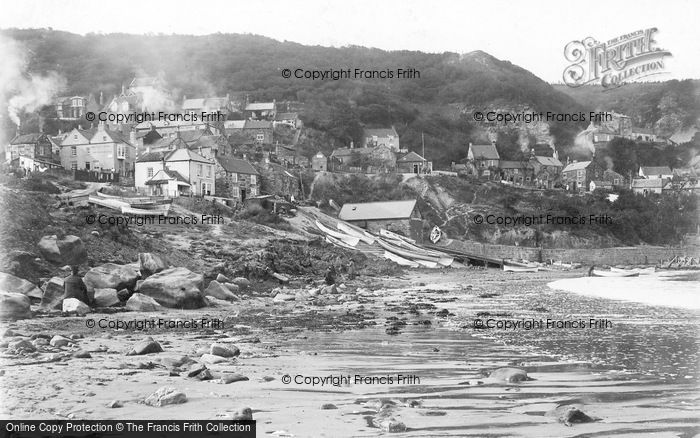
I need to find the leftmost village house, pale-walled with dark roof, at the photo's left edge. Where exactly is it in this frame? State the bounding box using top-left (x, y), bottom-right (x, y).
top-left (5, 133), bottom-right (61, 172)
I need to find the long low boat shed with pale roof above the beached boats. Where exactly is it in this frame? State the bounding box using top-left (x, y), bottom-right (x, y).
top-left (338, 199), bottom-right (423, 242)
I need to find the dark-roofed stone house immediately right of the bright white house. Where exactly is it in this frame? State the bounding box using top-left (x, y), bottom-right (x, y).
top-left (216, 156), bottom-right (261, 202)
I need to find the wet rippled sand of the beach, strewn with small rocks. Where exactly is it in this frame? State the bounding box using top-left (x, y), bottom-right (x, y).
top-left (0, 269), bottom-right (700, 437)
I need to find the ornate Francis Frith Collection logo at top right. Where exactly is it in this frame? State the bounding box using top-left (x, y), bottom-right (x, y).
top-left (564, 27), bottom-right (671, 88)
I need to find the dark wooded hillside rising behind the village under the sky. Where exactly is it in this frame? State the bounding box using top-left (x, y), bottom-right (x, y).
top-left (1, 29), bottom-right (583, 165)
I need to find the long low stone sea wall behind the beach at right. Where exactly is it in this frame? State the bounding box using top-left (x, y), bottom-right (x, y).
top-left (444, 240), bottom-right (700, 265)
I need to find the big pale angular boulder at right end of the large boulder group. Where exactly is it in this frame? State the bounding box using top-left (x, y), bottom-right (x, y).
top-left (138, 268), bottom-right (207, 309)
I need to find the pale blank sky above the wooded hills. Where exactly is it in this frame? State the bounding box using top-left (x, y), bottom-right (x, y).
top-left (0, 0), bottom-right (700, 82)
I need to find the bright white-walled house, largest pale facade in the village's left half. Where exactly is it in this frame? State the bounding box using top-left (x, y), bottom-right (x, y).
top-left (134, 147), bottom-right (216, 197)
